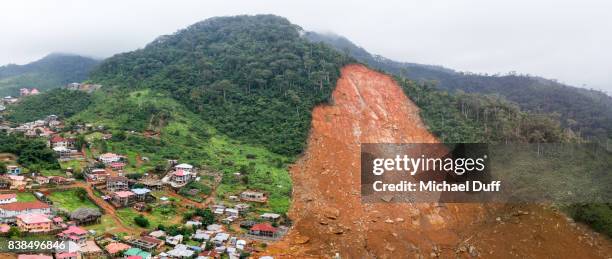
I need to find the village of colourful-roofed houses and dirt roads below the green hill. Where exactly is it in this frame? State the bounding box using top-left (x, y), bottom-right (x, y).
top-left (0, 83), bottom-right (290, 259)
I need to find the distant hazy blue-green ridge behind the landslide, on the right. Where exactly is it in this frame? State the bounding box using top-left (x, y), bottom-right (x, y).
top-left (306, 32), bottom-right (612, 142)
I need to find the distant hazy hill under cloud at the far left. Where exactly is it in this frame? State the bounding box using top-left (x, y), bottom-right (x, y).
top-left (0, 53), bottom-right (99, 96)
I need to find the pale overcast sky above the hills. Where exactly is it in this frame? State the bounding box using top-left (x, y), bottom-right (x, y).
top-left (0, 0), bottom-right (612, 93)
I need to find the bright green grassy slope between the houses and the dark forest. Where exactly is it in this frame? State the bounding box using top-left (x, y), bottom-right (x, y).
top-left (67, 88), bottom-right (293, 213)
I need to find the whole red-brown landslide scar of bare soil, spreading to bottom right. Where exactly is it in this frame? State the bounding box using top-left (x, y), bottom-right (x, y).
top-left (266, 65), bottom-right (612, 258)
